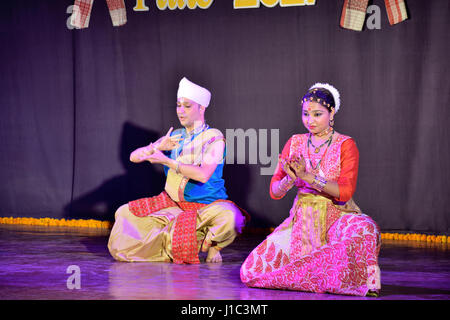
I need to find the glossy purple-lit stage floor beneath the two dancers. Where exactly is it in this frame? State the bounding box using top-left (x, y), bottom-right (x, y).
top-left (0, 225), bottom-right (450, 300)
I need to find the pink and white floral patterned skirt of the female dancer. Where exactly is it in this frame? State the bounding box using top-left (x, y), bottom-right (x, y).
top-left (240, 197), bottom-right (381, 296)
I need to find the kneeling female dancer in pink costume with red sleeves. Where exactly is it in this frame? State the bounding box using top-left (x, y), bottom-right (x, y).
top-left (241, 83), bottom-right (380, 296)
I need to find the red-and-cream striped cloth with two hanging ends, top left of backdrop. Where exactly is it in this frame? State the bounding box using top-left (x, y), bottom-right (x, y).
top-left (70, 0), bottom-right (127, 29)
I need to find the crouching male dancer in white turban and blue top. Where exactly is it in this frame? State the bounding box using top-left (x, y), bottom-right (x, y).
top-left (108, 78), bottom-right (245, 263)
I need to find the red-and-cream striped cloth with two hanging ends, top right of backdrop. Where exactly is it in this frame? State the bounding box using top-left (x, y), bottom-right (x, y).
top-left (340, 0), bottom-right (408, 31)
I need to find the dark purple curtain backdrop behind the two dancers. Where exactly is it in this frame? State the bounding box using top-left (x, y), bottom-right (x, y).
top-left (0, 0), bottom-right (450, 232)
